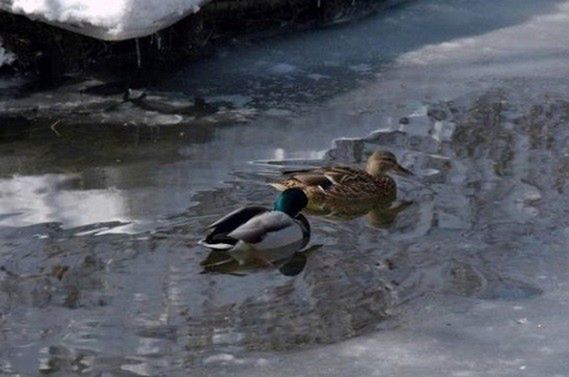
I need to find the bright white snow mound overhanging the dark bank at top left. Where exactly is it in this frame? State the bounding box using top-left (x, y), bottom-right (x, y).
top-left (0, 0), bottom-right (208, 40)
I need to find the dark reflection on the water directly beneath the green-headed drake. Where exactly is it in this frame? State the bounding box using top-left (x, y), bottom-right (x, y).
top-left (201, 245), bottom-right (322, 276)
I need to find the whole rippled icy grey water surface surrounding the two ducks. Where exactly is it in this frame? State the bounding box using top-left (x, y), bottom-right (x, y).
top-left (0, 0), bottom-right (569, 376)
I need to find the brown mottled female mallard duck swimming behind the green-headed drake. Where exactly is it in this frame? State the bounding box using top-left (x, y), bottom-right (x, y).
top-left (271, 151), bottom-right (413, 202)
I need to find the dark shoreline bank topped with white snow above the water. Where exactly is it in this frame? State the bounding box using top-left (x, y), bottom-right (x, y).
top-left (0, 0), bottom-right (390, 76)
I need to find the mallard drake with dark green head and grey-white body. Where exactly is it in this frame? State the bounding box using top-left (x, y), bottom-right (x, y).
top-left (199, 188), bottom-right (310, 265)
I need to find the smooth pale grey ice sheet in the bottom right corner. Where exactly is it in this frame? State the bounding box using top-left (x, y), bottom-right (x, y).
top-left (210, 292), bottom-right (569, 377)
